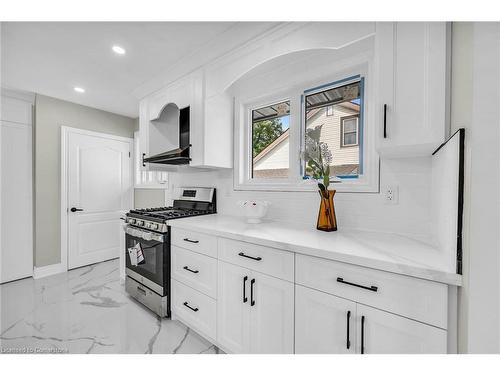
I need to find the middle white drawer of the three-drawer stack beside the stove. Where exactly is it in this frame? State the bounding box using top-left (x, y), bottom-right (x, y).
top-left (172, 246), bottom-right (217, 298)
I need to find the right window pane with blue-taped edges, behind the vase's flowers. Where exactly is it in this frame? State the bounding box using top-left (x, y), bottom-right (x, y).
top-left (304, 78), bottom-right (363, 179)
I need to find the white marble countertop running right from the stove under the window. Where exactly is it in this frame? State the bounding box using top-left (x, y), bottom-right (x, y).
top-left (168, 214), bottom-right (462, 286)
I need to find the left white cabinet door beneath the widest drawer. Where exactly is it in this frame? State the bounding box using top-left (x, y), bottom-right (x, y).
top-left (295, 285), bottom-right (356, 354)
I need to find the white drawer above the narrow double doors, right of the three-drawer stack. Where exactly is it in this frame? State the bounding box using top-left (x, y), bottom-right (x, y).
top-left (219, 238), bottom-right (294, 282)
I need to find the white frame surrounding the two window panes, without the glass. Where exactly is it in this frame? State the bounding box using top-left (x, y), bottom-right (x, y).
top-left (233, 63), bottom-right (379, 193)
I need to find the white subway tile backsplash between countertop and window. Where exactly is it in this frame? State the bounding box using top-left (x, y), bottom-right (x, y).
top-left (171, 158), bottom-right (431, 241)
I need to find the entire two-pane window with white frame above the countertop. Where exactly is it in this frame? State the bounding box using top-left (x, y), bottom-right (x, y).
top-left (233, 72), bottom-right (379, 192)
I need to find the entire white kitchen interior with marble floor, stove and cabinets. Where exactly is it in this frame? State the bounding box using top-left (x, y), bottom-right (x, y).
top-left (0, 2), bottom-right (500, 368)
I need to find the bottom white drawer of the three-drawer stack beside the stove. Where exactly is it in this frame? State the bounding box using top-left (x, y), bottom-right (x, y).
top-left (172, 280), bottom-right (217, 341)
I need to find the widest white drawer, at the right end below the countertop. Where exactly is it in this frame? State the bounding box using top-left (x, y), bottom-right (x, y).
top-left (295, 254), bottom-right (448, 329)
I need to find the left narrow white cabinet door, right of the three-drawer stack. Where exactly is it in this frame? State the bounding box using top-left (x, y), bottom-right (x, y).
top-left (217, 261), bottom-right (251, 353)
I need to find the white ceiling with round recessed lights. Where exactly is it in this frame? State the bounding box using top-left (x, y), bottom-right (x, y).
top-left (1, 22), bottom-right (276, 117)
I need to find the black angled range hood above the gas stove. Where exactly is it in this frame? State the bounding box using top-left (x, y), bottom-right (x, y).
top-left (146, 107), bottom-right (191, 165)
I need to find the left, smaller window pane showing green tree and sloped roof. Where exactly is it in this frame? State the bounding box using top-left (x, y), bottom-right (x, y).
top-left (251, 101), bottom-right (290, 179)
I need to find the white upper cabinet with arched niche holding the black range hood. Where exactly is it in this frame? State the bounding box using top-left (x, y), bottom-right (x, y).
top-left (139, 70), bottom-right (233, 171)
